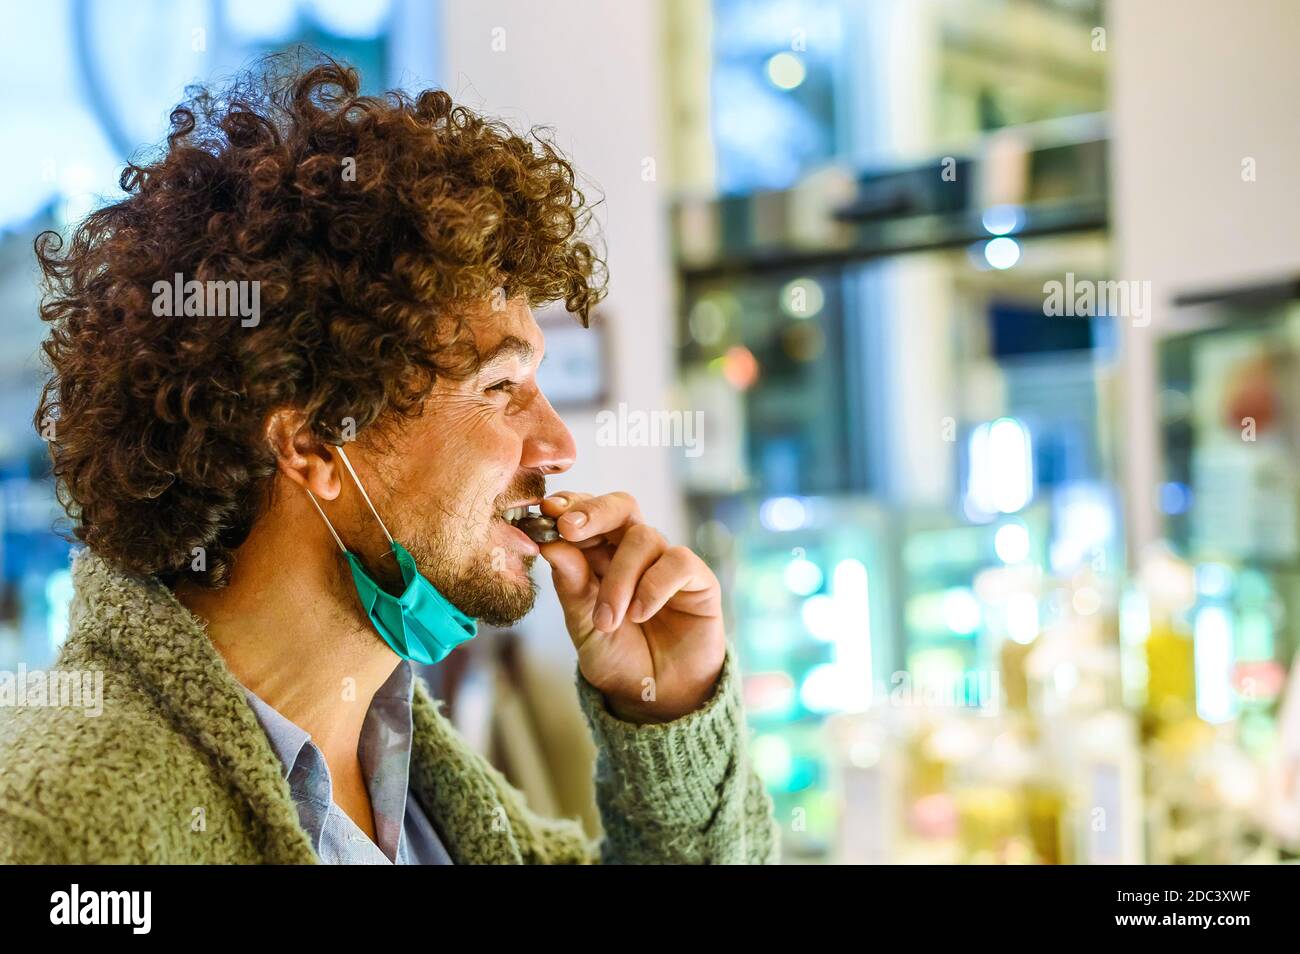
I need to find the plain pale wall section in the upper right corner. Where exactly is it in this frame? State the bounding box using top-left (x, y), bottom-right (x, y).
top-left (1106, 0), bottom-right (1300, 561)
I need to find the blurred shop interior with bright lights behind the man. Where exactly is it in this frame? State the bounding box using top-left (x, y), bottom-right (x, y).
top-left (0, 0), bottom-right (1300, 863)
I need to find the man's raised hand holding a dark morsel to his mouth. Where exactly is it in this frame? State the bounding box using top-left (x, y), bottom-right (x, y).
top-left (541, 491), bottom-right (727, 723)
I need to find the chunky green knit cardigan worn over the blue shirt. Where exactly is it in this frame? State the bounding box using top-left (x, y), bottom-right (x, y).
top-left (0, 550), bottom-right (779, 864)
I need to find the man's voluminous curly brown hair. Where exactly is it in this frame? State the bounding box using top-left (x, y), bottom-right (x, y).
top-left (35, 57), bottom-right (605, 586)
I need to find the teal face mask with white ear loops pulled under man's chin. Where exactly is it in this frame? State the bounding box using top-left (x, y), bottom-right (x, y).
top-left (307, 447), bottom-right (478, 663)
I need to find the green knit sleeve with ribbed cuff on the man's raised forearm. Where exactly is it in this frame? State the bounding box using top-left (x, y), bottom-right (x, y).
top-left (577, 646), bottom-right (779, 864)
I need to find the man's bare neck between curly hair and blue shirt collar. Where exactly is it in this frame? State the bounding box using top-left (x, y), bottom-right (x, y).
top-left (176, 486), bottom-right (400, 771)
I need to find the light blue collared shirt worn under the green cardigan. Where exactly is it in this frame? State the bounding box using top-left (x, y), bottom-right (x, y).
top-left (236, 659), bottom-right (452, 864)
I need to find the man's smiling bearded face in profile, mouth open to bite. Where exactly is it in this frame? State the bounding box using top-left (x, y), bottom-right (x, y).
top-left (345, 299), bottom-right (575, 625)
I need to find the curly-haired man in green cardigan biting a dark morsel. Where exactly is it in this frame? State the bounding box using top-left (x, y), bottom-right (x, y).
top-left (0, 62), bottom-right (776, 863)
